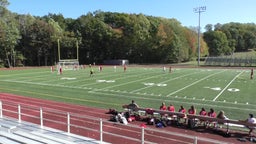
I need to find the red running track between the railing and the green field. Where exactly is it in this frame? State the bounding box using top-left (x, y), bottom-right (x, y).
top-left (0, 93), bottom-right (252, 144)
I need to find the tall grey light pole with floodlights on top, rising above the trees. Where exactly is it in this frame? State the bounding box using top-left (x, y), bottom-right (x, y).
top-left (194, 6), bottom-right (206, 66)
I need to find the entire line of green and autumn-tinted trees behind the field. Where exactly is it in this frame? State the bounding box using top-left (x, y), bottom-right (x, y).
top-left (0, 0), bottom-right (256, 66)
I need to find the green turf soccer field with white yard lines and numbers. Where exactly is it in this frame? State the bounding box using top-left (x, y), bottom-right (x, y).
top-left (0, 66), bottom-right (256, 119)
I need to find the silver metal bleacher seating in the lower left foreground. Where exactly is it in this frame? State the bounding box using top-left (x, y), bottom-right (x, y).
top-left (0, 118), bottom-right (107, 144)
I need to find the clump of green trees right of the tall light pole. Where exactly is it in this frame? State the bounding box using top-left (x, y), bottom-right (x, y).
top-left (203, 22), bottom-right (256, 56)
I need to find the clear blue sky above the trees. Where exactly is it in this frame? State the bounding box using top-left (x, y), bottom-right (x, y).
top-left (7, 0), bottom-right (256, 29)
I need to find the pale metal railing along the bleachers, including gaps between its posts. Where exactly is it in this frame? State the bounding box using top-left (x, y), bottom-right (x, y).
top-left (0, 101), bottom-right (228, 144)
